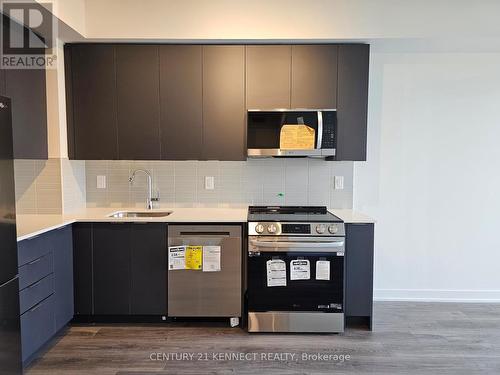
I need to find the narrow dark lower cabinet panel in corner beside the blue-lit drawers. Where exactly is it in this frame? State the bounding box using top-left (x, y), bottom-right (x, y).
top-left (73, 223), bottom-right (94, 315)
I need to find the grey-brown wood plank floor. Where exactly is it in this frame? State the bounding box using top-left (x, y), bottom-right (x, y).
top-left (27, 302), bottom-right (500, 375)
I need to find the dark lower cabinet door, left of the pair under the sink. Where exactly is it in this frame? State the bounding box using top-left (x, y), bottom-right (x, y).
top-left (93, 224), bottom-right (131, 315)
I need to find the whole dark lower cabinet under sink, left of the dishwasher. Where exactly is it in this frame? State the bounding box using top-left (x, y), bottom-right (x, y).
top-left (74, 223), bottom-right (167, 319)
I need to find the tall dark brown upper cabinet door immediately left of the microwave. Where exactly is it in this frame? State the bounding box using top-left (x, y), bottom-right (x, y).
top-left (202, 46), bottom-right (246, 160)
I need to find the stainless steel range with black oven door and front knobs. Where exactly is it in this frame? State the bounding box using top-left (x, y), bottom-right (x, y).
top-left (247, 206), bottom-right (345, 333)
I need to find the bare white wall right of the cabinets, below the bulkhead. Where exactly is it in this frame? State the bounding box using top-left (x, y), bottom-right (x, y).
top-left (354, 52), bottom-right (500, 300)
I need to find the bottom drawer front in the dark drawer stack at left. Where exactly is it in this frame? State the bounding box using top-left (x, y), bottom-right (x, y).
top-left (21, 295), bottom-right (55, 362)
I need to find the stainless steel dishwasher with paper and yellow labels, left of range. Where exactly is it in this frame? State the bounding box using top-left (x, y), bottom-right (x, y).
top-left (168, 225), bottom-right (242, 325)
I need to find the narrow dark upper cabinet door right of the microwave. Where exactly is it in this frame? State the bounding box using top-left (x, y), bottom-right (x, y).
top-left (336, 44), bottom-right (370, 160)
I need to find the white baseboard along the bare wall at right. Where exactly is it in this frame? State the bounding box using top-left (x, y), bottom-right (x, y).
top-left (373, 289), bottom-right (500, 303)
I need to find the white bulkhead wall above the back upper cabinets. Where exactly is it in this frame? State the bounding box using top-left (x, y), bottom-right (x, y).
top-left (82, 0), bottom-right (500, 40)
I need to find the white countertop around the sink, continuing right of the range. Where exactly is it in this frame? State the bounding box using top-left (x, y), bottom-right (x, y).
top-left (17, 207), bottom-right (375, 241)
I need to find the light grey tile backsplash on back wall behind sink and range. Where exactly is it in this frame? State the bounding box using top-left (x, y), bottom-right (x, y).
top-left (85, 158), bottom-right (353, 208)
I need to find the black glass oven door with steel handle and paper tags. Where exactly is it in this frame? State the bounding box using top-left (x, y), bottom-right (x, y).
top-left (247, 236), bottom-right (345, 313)
